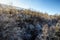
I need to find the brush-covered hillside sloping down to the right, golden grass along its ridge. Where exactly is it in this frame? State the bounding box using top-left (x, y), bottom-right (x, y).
top-left (0, 4), bottom-right (60, 40)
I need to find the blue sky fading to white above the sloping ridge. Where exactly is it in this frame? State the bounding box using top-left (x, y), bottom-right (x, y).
top-left (0, 0), bottom-right (60, 15)
